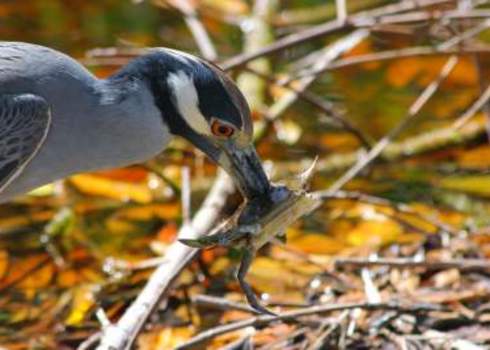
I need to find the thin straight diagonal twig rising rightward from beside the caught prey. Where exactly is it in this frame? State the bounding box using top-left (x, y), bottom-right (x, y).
top-left (329, 56), bottom-right (458, 192)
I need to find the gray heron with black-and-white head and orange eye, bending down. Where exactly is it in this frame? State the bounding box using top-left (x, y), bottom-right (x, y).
top-left (0, 42), bottom-right (270, 202)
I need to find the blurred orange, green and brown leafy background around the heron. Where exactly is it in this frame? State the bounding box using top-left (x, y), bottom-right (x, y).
top-left (0, 0), bottom-right (490, 349)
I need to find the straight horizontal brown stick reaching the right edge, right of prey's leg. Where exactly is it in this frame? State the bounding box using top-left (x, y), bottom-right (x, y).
top-left (334, 258), bottom-right (490, 270)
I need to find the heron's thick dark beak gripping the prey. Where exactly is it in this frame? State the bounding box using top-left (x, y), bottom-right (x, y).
top-left (218, 142), bottom-right (271, 199)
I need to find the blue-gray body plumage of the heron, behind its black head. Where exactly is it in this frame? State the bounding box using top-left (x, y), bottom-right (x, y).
top-left (0, 42), bottom-right (170, 202)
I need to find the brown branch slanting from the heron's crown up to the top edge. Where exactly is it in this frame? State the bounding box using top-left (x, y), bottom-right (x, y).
top-left (221, 0), bottom-right (452, 69)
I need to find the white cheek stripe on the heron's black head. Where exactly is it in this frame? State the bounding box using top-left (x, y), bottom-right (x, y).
top-left (167, 71), bottom-right (211, 135)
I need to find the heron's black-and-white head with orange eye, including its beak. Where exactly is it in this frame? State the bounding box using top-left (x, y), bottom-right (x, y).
top-left (145, 49), bottom-right (270, 198)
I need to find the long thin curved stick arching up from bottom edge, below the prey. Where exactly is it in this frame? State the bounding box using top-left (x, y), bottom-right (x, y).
top-left (176, 303), bottom-right (442, 350)
